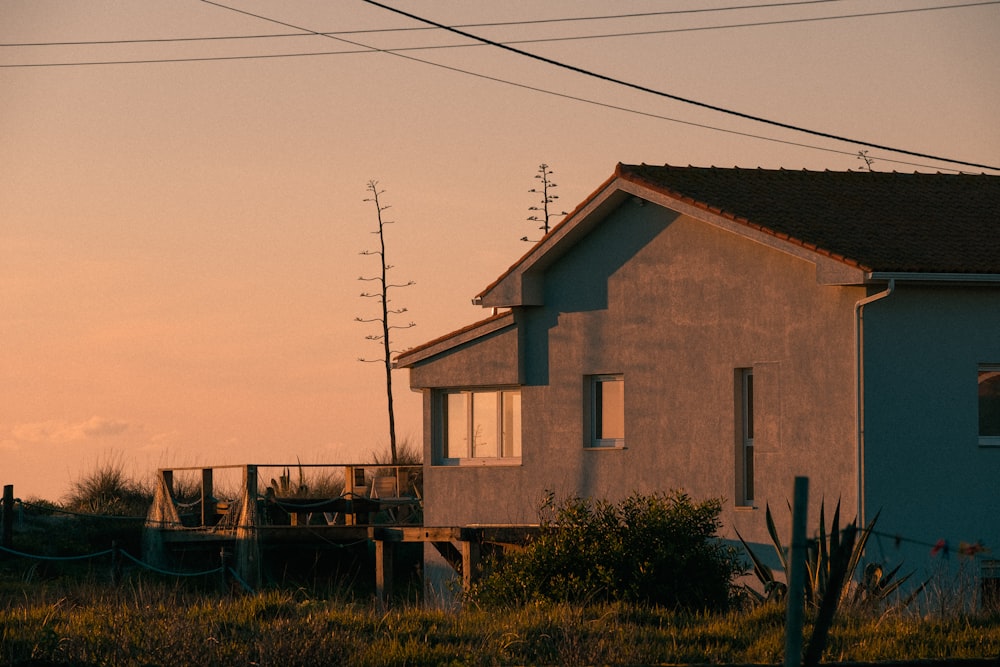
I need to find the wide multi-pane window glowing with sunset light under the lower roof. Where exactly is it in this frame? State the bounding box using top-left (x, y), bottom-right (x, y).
top-left (440, 389), bottom-right (521, 460)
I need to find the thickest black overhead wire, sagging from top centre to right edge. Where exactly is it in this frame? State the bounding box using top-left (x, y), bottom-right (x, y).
top-left (360, 0), bottom-right (1000, 171)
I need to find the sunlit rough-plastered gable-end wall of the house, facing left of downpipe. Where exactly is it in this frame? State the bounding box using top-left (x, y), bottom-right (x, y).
top-left (414, 200), bottom-right (865, 542)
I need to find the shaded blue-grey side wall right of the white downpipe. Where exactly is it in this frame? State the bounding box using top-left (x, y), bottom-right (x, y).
top-left (863, 283), bottom-right (1000, 571)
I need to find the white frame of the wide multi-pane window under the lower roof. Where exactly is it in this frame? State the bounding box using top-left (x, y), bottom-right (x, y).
top-left (435, 387), bottom-right (523, 465)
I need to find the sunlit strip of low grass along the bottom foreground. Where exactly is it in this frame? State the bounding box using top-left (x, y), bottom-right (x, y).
top-left (0, 578), bottom-right (1000, 667)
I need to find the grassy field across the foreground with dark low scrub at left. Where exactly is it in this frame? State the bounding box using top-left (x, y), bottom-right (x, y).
top-left (0, 464), bottom-right (1000, 667)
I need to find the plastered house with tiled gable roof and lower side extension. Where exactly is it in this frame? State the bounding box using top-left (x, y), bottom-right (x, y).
top-left (396, 164), bottom-right (1000, 592)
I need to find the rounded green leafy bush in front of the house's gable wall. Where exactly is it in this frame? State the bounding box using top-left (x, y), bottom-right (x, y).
top-left (471, 492), bottom-right (743, 610)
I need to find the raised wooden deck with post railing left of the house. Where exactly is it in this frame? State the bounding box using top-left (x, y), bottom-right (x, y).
top-left (147, 464), bottom-right (538, 607)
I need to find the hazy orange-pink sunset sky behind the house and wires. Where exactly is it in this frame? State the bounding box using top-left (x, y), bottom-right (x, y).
top-left (0, 0), bottom-right (1000, 500)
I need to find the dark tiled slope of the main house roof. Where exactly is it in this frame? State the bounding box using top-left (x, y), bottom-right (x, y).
top-left (616, 164), bottom-right (1000, 274)
